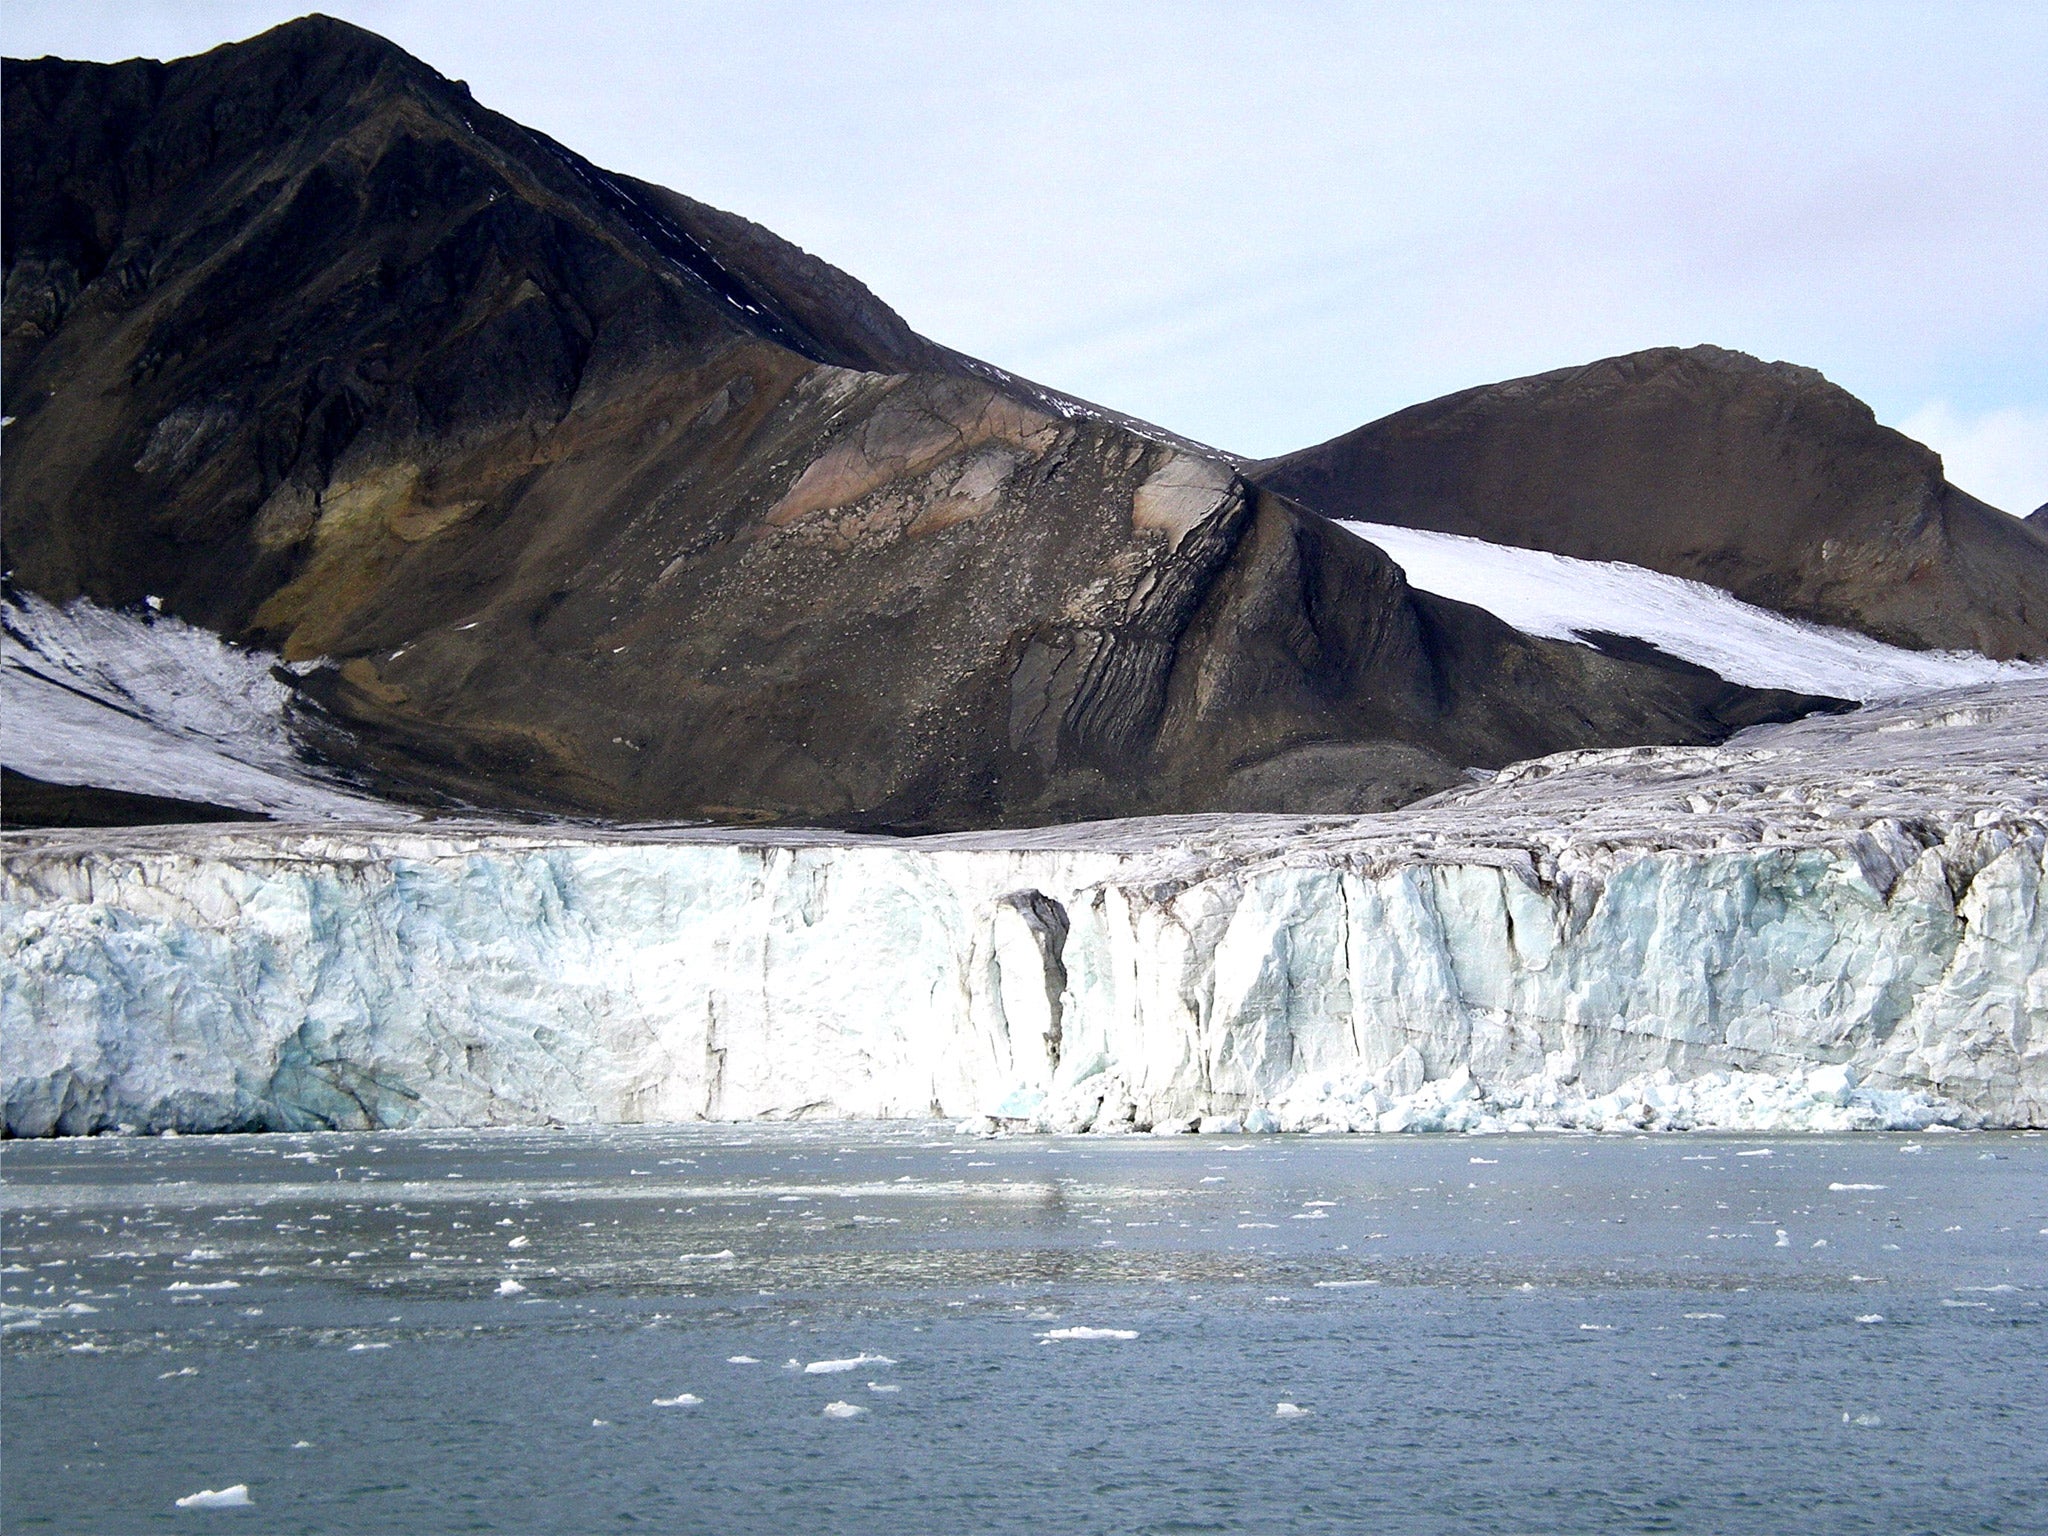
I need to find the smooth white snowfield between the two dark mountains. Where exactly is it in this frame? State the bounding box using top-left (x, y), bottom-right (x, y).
top-left (1339, 522), bottom-right (2048, 702)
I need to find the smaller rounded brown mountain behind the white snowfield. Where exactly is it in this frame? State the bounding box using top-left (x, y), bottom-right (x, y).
top-left (1253, 346), bottom-right (2048, 659)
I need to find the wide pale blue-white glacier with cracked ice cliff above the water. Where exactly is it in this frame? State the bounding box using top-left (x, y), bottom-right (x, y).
top-left (0, 680), bottom-right (2048, 1135)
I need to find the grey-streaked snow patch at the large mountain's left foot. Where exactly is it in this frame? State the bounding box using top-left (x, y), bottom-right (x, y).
top-left (0, 592), bottom-right (395, 821)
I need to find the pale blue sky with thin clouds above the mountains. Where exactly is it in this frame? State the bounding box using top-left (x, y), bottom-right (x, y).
top-left (16, 0), bottom-right (2048, 512)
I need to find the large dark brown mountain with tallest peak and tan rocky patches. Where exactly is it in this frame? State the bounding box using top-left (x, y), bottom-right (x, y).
top-left (4, 18), bottom-right (1843, 827)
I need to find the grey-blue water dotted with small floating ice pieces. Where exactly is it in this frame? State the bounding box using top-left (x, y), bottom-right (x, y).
top-left (0, 1124), bottom-right (2048, 1536)
